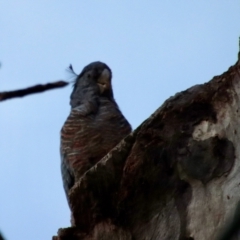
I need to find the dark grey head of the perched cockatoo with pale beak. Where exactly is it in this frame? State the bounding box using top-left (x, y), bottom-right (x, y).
top-left (71, 62), bottom-right (113, 106)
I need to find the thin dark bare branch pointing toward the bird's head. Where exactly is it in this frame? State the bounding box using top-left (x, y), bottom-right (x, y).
top-left (0, 81), bottom-right (69, 101)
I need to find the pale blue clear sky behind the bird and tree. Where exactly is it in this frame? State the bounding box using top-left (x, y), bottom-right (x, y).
top-left (0, 0), bottom-right (240, 240)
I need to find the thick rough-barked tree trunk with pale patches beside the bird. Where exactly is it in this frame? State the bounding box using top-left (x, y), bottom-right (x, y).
top-left (54, 60), bottom-right (240, 240)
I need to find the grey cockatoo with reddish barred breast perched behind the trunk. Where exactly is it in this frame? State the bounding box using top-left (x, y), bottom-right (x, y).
top-left (60, 62), bottom-right (131, 204)
